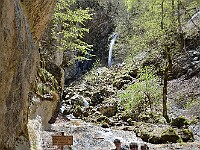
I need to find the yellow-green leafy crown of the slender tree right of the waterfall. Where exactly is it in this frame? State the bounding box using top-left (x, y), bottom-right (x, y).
top-left (126, 0), bottom-right (199, 60)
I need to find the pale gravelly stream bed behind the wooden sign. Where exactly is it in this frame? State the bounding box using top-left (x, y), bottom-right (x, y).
top-left (41, 119), bottom-right (200, 150)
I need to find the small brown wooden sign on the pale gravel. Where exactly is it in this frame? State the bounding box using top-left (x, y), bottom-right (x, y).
top-left (52, 133), bottom-right (73, 146)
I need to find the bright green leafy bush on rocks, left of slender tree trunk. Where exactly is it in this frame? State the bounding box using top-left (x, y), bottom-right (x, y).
top-left (119, 67), bottom-right (162, 114)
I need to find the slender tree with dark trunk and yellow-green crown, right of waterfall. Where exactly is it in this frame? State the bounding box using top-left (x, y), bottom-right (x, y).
top-left (127, 0), bottom-right (198, 122)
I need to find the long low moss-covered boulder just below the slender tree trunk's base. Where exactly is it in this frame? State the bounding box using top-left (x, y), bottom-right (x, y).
top-left (133, 122), bottom-right (194, 144)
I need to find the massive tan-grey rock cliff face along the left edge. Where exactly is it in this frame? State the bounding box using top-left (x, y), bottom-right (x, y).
top-left (0, 0), bottom-right (55, 150)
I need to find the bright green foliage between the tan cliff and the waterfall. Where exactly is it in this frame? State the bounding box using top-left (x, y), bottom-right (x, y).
top-left (52, 0), bottom-right (91, 55)
